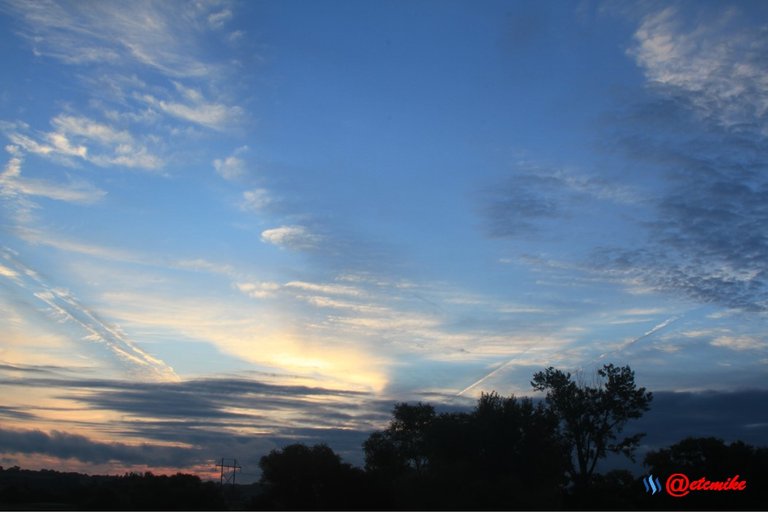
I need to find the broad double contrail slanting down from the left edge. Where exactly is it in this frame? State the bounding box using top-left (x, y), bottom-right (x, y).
top-left (0, 248), bottom-right (179, 381)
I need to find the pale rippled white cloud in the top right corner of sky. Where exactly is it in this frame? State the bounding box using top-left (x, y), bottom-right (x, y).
top-left (629, 6), bottom-right (768, 128)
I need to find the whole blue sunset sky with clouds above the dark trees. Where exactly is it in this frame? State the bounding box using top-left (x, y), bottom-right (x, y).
top-left (0, 0), bottom-right (768, 479)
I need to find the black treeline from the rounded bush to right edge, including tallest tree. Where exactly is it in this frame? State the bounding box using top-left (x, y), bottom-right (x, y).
top-left (255, 365), bottom-right (768, 511)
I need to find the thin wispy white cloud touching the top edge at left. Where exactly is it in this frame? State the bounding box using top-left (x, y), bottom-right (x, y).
top-left (8, 1), bottom-right (229, 77)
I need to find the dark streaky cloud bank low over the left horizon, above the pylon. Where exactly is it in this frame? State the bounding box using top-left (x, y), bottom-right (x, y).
top-left (0, 374), bottom-right (384, 471)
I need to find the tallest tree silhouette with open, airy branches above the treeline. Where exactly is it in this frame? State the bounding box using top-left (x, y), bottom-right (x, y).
top-left (531, 364), bottom-right (653, 488)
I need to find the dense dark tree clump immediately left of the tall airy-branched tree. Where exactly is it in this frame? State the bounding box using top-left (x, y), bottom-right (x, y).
top-left (364, 393), bottom-right (567, 510)
